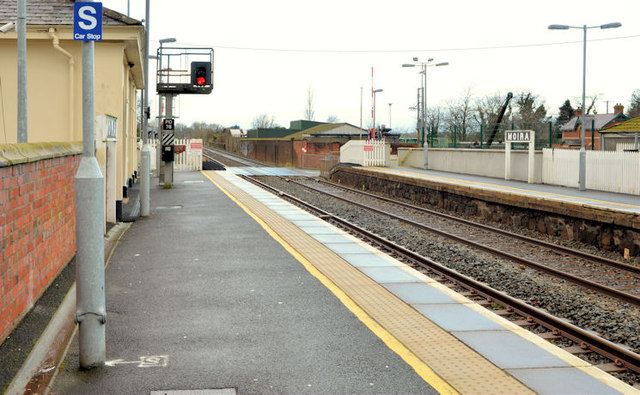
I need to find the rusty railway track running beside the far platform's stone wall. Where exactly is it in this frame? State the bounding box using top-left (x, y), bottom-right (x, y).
top-left (288, 180), bottom-right (640, 307)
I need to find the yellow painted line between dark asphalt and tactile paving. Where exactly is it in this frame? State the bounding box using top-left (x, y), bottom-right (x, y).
top-left (201, 171), bottom-right (458, 394)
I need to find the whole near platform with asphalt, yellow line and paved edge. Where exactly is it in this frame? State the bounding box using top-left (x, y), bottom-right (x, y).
top-left (10, 169), bottom-right (639, 395)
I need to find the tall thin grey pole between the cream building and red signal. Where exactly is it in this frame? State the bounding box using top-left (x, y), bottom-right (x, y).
top-left (140, 0), bottom-right (151, 217)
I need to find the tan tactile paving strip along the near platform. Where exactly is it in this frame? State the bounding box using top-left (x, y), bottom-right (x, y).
top-left (207, 172), bottom-right (533, 394)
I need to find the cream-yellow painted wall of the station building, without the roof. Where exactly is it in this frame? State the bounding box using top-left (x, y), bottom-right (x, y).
top-left (0, 26), bottom-right (144, 204)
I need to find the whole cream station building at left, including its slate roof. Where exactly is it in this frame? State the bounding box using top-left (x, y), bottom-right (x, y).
top-left (0, 0), bottom-right (145, 222)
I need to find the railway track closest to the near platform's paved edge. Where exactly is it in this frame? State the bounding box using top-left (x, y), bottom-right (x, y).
top-left (243, 176), bottom-right (640, 382)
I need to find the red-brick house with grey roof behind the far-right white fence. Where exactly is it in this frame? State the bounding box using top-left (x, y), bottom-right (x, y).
top-left (560, 104), bottom-right (629, 150)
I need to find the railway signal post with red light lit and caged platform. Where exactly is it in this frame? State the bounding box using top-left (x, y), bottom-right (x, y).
top-left (156, 47), bottom-right (213, 188)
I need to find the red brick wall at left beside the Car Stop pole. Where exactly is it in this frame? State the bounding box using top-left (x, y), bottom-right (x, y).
top-left (0, 155), bottom-right (81, 343)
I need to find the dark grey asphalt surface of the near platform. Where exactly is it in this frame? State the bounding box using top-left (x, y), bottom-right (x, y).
top-left (51, 173), bottom-right (435, 394)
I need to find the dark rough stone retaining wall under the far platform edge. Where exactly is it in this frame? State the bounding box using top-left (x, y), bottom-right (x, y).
top-left (331, 166), bottom-right (640, 256)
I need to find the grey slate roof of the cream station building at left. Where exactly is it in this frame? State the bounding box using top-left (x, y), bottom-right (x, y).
top-left (0, 0), bottom-right (142, 26)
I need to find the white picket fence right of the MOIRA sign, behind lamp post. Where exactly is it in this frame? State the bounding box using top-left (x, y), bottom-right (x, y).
top-left (542, 148), bottom-right (640, 195)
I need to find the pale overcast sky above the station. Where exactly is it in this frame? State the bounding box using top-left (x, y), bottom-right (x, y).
top-left (103, 0), bottom-right (640, 131)
